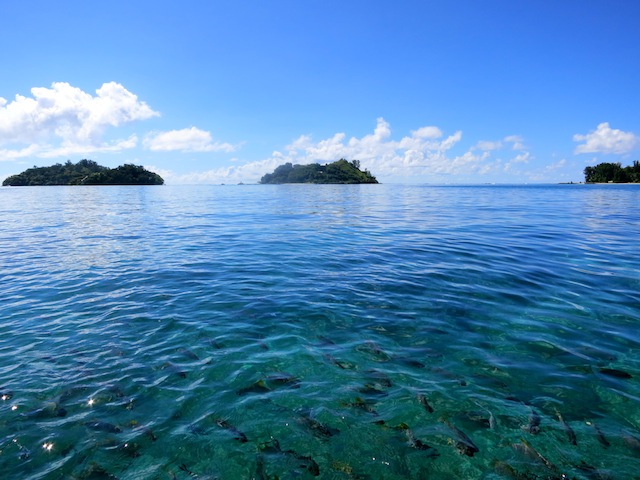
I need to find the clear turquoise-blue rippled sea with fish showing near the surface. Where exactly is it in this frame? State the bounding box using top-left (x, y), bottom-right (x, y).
top-left (0, 185), bottom-right (640, 480)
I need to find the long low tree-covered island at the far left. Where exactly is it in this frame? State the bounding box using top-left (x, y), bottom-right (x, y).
top-left (2, 159), bottom-right (164, 187)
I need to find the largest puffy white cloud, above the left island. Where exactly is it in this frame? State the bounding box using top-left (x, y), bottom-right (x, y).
top-left (0, 82), bottom-right (158, 158)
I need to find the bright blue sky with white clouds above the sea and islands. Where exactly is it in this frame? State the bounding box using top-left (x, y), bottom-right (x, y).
top-left (0, 0), bottom-right (640, 184)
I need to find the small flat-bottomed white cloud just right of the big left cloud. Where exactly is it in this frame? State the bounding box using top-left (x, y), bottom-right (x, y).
top-left (144, 127), bottom-right (236, 152)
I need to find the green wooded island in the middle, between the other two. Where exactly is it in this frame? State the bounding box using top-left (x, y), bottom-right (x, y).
top-left (260, 158), bottom-right (378, 184)
